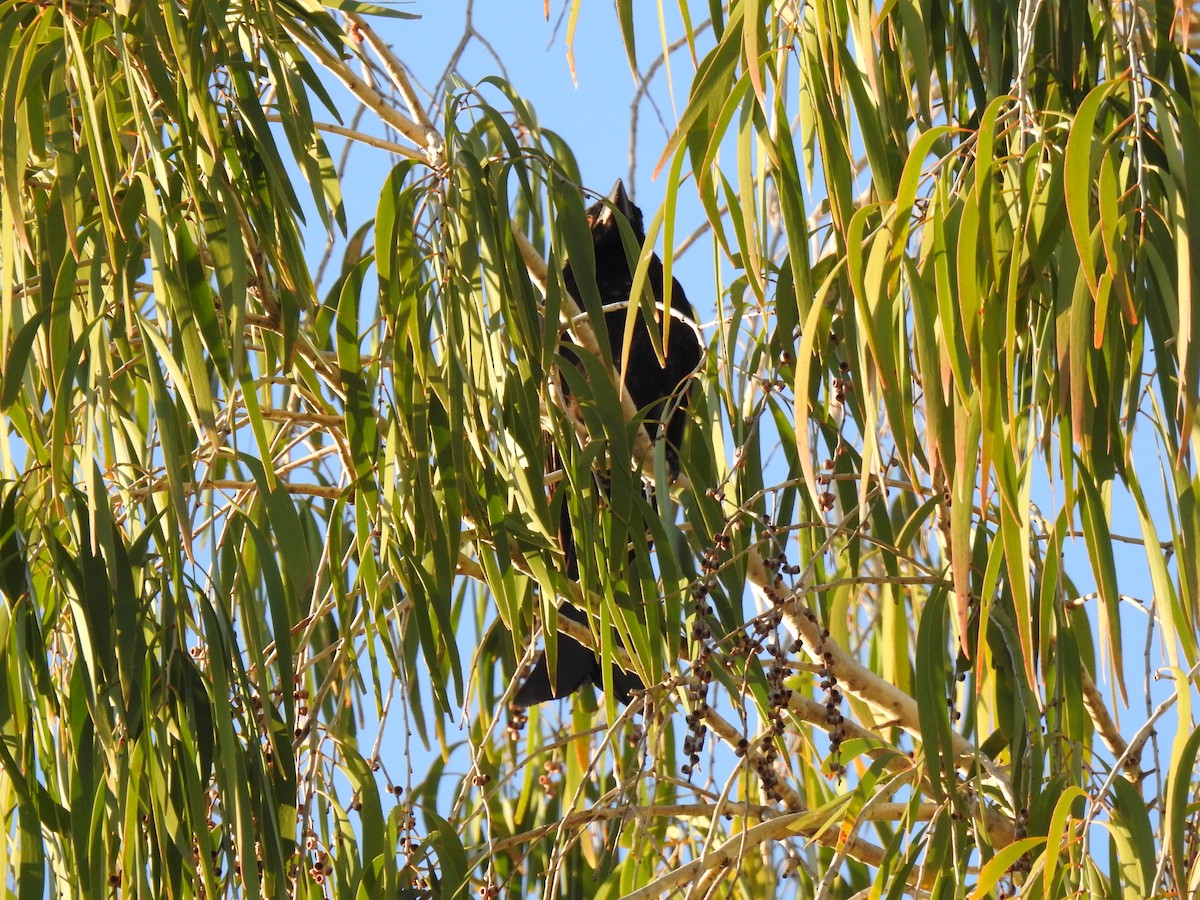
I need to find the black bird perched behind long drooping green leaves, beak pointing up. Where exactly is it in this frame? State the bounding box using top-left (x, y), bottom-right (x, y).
top-left (514, 181), bottom-right (701, 707)
